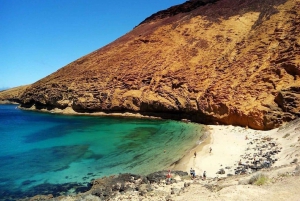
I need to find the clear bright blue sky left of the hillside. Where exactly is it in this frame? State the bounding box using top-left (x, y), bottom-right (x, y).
top-left (0, 0), bottom-right (185, 90)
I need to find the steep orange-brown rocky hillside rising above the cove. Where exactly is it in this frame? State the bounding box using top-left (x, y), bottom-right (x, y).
top-left (2, 0), bottom-right (300, 129)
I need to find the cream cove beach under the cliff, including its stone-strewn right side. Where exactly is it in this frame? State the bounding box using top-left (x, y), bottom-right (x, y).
top-left (173, 122), bottom-right (299, 178)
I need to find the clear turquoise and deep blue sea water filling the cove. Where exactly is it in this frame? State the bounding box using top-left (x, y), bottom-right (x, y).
top-left (0, 105), bottom-right (203, 199)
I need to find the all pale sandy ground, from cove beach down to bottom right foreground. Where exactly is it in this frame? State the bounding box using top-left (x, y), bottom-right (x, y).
top-left (95, 120), bottom-right (300, 201)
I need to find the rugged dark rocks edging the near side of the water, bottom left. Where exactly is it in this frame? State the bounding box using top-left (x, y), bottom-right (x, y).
top-left (16, 171), bottom-right (190, 201)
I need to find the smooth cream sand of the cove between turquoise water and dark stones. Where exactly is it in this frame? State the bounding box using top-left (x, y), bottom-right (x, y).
top-left (174, 126), bottom-right (284, 177)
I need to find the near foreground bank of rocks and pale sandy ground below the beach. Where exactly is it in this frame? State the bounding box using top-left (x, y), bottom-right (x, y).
top-left (20, 164), bottom-right (300, 201)
